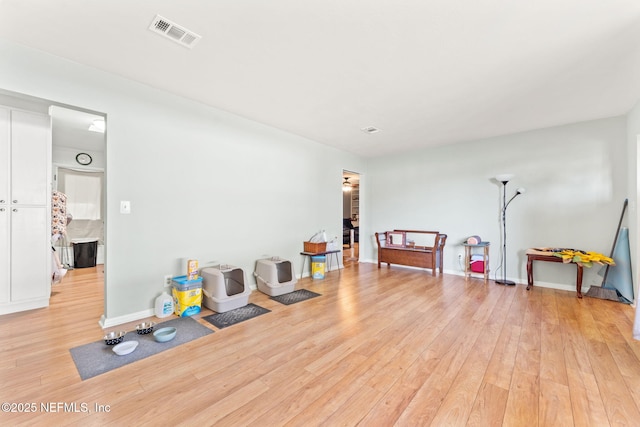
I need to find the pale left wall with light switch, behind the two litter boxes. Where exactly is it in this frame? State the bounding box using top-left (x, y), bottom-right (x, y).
top-left (0, 41), bottom-right (363, 324)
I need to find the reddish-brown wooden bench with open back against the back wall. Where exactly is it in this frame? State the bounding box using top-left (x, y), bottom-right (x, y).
top-left (376, 230), bottom-right (447, 276)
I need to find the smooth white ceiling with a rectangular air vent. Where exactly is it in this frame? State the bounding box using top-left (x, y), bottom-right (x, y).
top-left (0, 0), bottom-right (640, 156)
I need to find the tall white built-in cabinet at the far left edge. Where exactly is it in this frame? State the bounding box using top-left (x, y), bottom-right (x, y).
top-left (0, 106), bottom-right (52, 314)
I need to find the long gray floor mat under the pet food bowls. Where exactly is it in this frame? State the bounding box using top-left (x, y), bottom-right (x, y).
top-left (69, 317), bottom-right (214, 381)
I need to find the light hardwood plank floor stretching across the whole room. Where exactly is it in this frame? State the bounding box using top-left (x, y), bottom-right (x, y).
top-left (0, 263), bottom-right (640, 427)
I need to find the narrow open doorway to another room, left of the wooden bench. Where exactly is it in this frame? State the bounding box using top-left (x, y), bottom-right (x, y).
top-left (342, 170), bottom-right (361, 268)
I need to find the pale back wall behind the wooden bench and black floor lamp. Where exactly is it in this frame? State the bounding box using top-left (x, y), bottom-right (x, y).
top-left (365, 117), bottom-right (629, 290)
